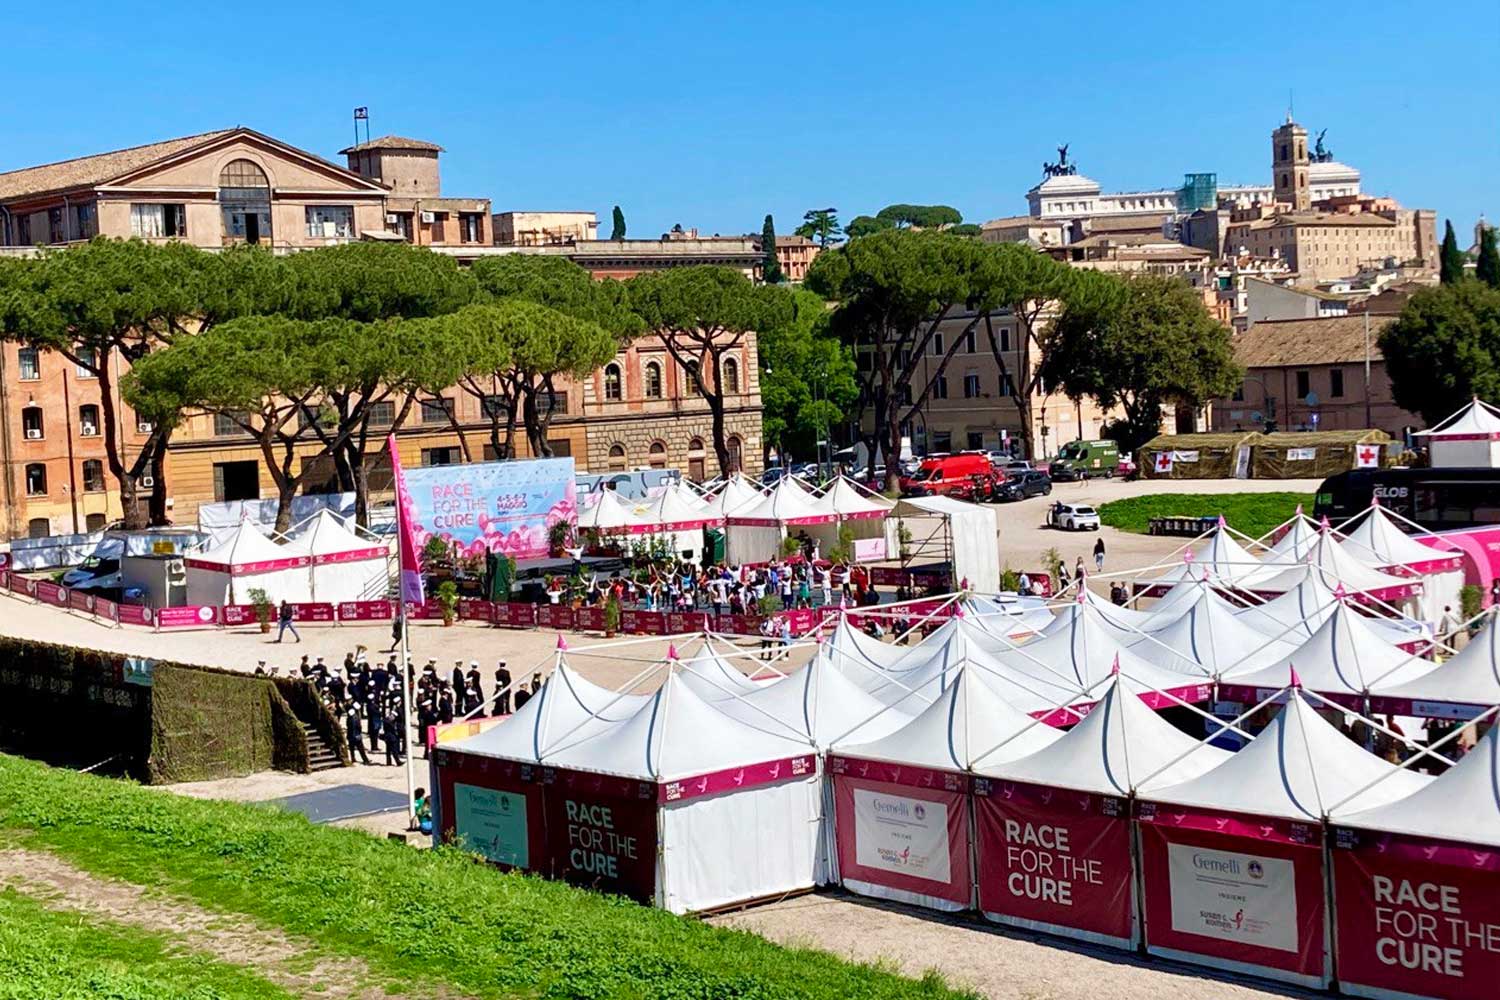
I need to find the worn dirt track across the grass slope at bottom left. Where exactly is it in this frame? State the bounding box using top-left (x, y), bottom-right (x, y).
top-left (0, 850), bottom-right (474, 1000)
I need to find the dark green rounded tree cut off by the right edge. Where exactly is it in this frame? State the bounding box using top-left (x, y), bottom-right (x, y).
top-left (1379, 280), bottom-right (1500, 424)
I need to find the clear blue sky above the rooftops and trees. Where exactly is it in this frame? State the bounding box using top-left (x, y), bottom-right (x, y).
top-left (0, 0), bottom-right (1500, 239)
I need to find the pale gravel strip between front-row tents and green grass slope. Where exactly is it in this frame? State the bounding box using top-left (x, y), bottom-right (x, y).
top-left (711, 894), bottom-right (1313, 1000)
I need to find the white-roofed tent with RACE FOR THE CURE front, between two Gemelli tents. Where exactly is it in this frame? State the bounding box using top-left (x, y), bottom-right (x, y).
top-left (974, 676), bottom-right (1227, 948)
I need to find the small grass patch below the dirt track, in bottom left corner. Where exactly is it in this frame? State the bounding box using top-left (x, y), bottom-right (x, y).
top-left (0, 892), bottom-right (293, 1000)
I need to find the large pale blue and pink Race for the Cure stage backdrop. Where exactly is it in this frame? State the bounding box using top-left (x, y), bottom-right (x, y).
top-left (402, 459), bottom-right (578, 559)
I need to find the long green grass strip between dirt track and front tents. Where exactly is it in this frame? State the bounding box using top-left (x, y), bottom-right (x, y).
top-left (0, 756), bottom-right (978, 1000)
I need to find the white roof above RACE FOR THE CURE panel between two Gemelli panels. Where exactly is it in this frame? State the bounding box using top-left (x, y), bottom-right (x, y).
top-left (975, 676), bottom-right (1229, 795)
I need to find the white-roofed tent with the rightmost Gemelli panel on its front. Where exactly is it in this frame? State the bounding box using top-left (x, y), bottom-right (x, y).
top-left (1137, 691), bottom-right (1430, 988)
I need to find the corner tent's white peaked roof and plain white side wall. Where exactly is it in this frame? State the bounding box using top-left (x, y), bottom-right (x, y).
top-left (549, 673), bottom-right (822, 913)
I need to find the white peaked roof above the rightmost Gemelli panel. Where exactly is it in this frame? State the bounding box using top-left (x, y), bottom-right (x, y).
top-left (1148, 693), bottom-right (1430, 822)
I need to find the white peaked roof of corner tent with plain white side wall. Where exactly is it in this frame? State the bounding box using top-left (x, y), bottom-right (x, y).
top-left (548, 672), bottom-right (812, 781)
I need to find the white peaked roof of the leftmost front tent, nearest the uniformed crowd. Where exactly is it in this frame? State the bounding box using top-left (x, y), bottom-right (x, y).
top-left (453, 663), bottom-right (648, 762)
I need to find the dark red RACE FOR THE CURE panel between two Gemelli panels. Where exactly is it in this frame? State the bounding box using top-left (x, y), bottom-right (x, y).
top-left (974, 778), bottom-right (1136, 948)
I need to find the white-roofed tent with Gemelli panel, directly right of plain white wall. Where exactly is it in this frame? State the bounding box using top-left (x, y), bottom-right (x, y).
top-left (830, 666), bottom-right (1059, 910)
